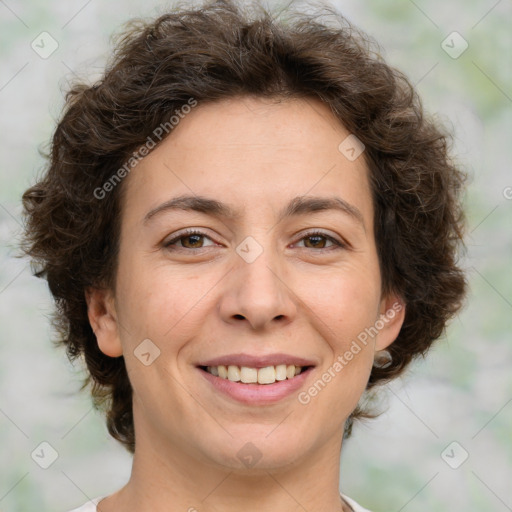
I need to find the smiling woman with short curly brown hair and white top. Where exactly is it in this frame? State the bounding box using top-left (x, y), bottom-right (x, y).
top-left (23, 1), bottom-right (465, 512)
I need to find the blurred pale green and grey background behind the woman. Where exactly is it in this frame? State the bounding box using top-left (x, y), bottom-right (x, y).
top-left (0, 0), bottom-right (512, 512)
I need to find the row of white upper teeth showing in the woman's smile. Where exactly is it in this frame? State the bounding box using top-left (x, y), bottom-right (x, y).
top-left (206, 364), bottom-right (302, 384)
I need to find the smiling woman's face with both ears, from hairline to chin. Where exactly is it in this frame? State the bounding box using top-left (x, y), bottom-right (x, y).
top-left (88, 97), bottom-right (403, 470)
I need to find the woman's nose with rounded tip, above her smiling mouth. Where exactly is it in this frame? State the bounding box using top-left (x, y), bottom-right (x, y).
top-left (220, 251), bottom-right (297, 330)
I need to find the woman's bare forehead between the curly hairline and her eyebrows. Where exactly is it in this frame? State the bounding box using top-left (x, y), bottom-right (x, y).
top-left (121, 97), bottom-right (371, 228)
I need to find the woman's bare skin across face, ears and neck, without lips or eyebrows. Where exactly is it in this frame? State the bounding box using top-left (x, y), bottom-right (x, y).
top-left (86, 97), bottom-right (405, 512)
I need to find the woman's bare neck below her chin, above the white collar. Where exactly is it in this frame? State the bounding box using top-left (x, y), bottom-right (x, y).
top-left (98, 422), bottom-right (351, 512)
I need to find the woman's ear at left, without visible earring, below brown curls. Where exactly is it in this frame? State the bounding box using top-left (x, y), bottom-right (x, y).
top-left (85, 288), bottom-right (123, 357)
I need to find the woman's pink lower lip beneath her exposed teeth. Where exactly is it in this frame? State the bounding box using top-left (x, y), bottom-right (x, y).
top-left (197, 367), bottom-right (313, 405)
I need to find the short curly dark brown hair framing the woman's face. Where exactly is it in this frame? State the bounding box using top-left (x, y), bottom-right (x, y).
top-left (21, 0), bottom-right (466, 453)
